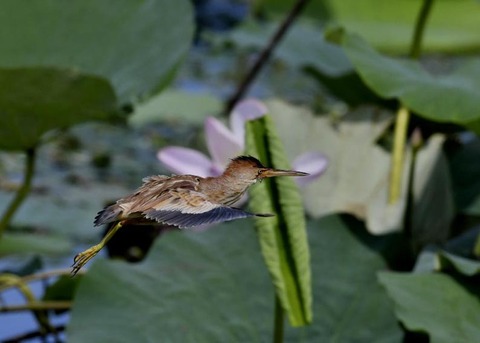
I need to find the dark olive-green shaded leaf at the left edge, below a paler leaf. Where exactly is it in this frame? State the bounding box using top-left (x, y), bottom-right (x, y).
top-left (0, 68), bottom-right (119, 150)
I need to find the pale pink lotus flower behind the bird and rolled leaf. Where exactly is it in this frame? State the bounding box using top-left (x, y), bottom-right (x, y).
top-left (157, 99), bottom-right (327, 196)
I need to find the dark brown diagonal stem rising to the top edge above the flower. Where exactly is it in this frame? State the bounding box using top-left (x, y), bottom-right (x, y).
top-left (224, 0), bottom-right (310, 115)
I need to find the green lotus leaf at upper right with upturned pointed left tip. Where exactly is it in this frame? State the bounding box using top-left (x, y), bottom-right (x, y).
top-left (343, 33), bottom-right (480, 132)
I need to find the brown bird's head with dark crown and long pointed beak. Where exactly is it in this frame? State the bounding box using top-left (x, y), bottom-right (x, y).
top-left (225, 156), bottom-right (309, 183)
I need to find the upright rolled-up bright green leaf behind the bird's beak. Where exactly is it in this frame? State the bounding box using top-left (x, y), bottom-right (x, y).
top-left (245, 116), bottom-right (312, 326)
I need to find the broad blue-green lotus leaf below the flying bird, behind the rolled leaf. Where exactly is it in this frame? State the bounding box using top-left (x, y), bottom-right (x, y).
top-left (68, 216), bottom-right (402, 343)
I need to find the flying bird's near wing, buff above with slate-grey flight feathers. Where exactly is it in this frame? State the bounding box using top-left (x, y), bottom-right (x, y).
top-left (143, 189), bottom-right (255, 228)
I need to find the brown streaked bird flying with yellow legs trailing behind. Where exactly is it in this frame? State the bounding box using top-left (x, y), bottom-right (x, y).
top-left (72, 156), bottom-right (309, 276)
